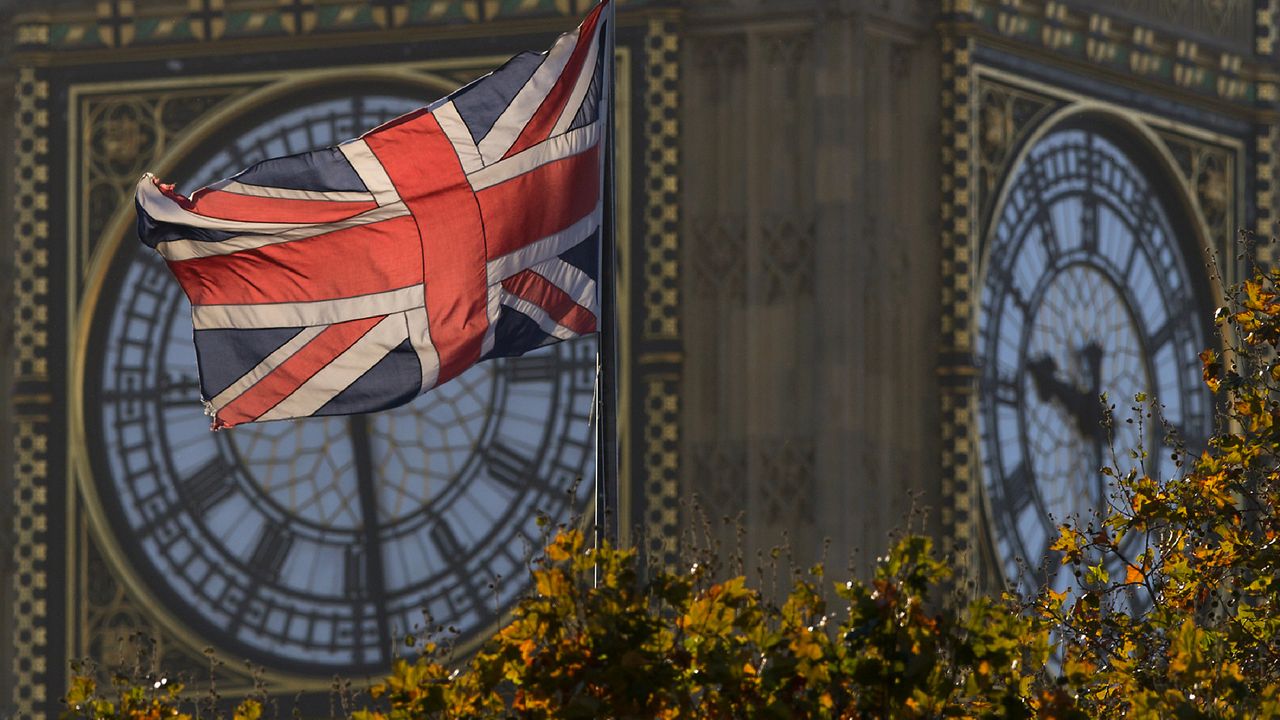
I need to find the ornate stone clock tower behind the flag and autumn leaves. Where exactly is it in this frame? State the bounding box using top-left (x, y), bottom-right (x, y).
top-left (0, 0), bottom-right (1280, 717)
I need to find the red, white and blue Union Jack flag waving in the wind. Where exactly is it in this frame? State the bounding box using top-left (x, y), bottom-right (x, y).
top-left (136, 0), bottom-right (612, 429)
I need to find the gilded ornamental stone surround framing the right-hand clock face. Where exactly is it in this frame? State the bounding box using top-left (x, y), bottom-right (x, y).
top-left (938, 0), bottom-right (1259, 588)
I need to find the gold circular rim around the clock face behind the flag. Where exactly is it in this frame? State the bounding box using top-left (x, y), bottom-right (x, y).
top-left (68, 70), bottom-right (601, 689)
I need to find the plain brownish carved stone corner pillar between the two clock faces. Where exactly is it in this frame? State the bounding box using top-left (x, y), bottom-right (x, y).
top-left (684, 1), bottom-right (940, 564)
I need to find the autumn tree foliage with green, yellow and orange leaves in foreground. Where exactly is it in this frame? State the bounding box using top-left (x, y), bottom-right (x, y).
top-left (65, 266), bottom-right (1280, 720)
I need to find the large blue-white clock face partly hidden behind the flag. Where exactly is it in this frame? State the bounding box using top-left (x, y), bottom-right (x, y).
top-left (86, 96), bottom-right (595, 676)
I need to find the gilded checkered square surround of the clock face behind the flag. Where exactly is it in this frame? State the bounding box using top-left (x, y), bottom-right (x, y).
top-left (2, 0), bottom-right (680, 717)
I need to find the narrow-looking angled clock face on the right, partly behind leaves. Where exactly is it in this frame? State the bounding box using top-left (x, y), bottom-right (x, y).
top-left (978, 129), bottom-right (1211, 589)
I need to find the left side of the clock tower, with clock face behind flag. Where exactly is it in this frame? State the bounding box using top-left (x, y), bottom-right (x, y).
top-left (0, 0), bottom-right (680, 719)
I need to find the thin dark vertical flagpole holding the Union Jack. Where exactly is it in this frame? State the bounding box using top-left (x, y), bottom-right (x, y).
top-left (595, 0), bottom-right (625, 547)
